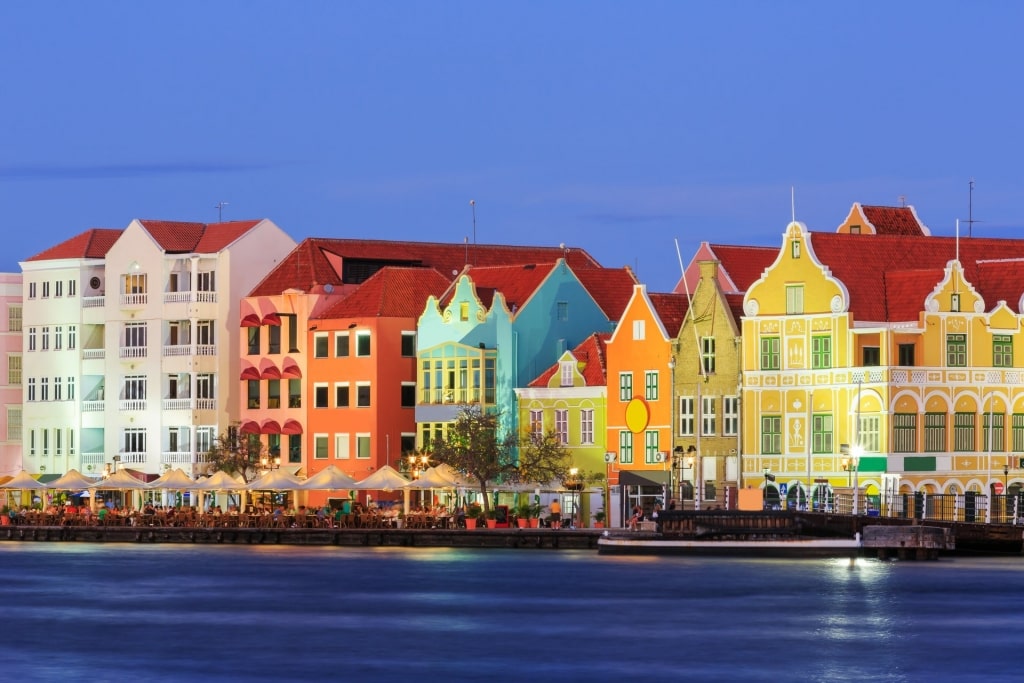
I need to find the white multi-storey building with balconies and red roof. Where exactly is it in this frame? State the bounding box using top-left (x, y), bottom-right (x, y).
top-left (20, 220), bottom-right (295, 476)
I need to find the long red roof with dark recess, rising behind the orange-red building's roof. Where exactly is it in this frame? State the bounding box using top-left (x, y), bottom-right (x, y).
top-left (249, 238), bottom-right (601, 296)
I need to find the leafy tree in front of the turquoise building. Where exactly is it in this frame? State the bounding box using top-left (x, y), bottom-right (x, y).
top-left (430, 407), bottom-right (517, 512)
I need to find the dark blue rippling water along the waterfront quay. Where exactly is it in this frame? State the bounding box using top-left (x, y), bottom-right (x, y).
top-left (0, 543), bottom-right (1024, 683)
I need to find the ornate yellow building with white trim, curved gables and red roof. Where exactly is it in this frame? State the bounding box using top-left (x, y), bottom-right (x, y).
top-left (742, 204), bottom-right (1024, 516)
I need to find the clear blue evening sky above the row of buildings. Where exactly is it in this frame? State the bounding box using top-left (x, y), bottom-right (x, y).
top-left (0, 0), bottom-right (1024, 291)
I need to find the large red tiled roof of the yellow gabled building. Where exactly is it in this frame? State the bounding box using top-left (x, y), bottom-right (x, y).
top-left (809, 232), bottom-right (1024, 323)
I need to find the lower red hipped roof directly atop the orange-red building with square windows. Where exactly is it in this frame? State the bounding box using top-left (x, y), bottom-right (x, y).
top-left (310, 266), bottom-right (449, 319)
